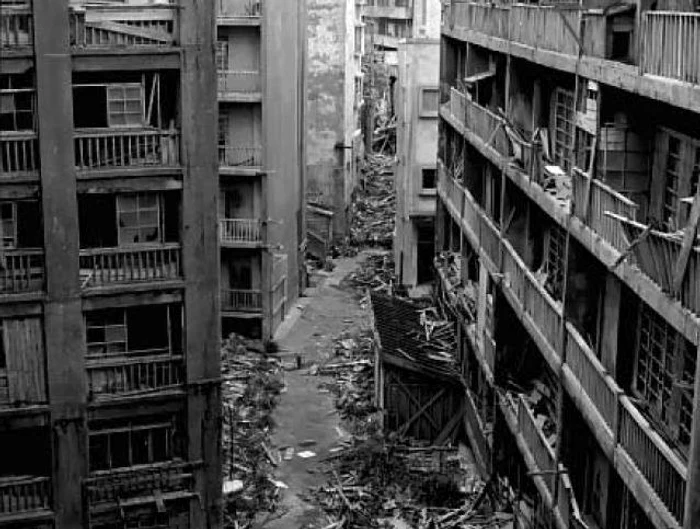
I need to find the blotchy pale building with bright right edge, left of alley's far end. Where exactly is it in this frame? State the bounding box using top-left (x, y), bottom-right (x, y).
top-left (306, 0), bottom-right (364, 242)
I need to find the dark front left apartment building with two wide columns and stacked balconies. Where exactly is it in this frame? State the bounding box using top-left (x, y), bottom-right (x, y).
top-left (0, 0), bottom-right (221, 529)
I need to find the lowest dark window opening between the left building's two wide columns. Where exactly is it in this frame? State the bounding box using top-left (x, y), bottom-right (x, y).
top-left (88, 416), bottom-right (179, 472)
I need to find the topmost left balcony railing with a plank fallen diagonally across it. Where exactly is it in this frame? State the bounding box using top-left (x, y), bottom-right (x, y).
top-left (70, 0), bottom-right (179, 48)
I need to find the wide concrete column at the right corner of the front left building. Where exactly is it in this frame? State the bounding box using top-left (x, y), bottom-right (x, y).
top-left (180, 0), bottom-right (222, 529)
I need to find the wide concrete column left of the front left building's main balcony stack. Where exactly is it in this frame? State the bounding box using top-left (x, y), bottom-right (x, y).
top-left (33, 0), bottom-right (88, 529)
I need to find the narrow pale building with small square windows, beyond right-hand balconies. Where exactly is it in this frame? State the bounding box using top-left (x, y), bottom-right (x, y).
top-left (394, 38), bottom-right (440, 287)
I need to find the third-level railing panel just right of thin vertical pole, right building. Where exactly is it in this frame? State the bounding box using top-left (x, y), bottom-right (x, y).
top-left (566, 323), bottom-right (622, 432)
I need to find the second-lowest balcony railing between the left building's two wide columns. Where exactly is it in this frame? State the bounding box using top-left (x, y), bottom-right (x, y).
top-left (87, 353), bottom-right (185, 398)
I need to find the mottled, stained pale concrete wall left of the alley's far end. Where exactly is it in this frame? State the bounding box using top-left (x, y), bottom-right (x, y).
top-left (306, 0), bottom-right (356, 237)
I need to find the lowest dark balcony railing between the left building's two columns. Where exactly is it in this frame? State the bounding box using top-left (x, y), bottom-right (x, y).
top-left (83, 462), bottom-right (194, 506)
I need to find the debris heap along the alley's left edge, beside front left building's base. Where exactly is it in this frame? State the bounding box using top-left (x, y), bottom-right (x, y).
top-left (221, 335), bottom-right (284, 529)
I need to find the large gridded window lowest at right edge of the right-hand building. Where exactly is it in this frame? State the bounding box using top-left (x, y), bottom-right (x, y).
top-left (633, 305), bottom-right (697, 455)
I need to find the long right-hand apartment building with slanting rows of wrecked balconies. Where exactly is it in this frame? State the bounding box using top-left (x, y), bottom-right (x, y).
top-left (436, 0), bottom-right (700, 529)
